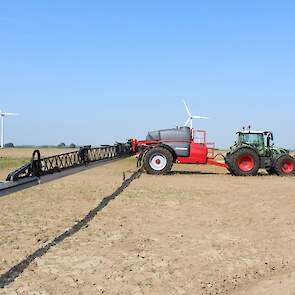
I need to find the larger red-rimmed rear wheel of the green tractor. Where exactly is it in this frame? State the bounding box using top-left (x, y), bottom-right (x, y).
top-left (228, 148), bottom-right (260, 176)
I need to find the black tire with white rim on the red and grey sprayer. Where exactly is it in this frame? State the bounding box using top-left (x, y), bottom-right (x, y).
top-left (143, 147), bottom-right (173, 175)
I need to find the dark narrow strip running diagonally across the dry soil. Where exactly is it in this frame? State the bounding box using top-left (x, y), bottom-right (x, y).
top-left (0, 169), bottom-right (142, 289)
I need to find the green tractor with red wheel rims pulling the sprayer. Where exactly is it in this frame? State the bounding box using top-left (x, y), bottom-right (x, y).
top-left (225, 128), bottom-right (295, 176)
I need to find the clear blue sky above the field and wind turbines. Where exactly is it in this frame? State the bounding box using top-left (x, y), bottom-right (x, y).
top-left (0, 0), bottom-right (295, 147)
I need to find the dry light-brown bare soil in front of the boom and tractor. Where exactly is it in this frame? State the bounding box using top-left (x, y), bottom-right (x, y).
top-left (0, 159), bottom-right (295, 295)
